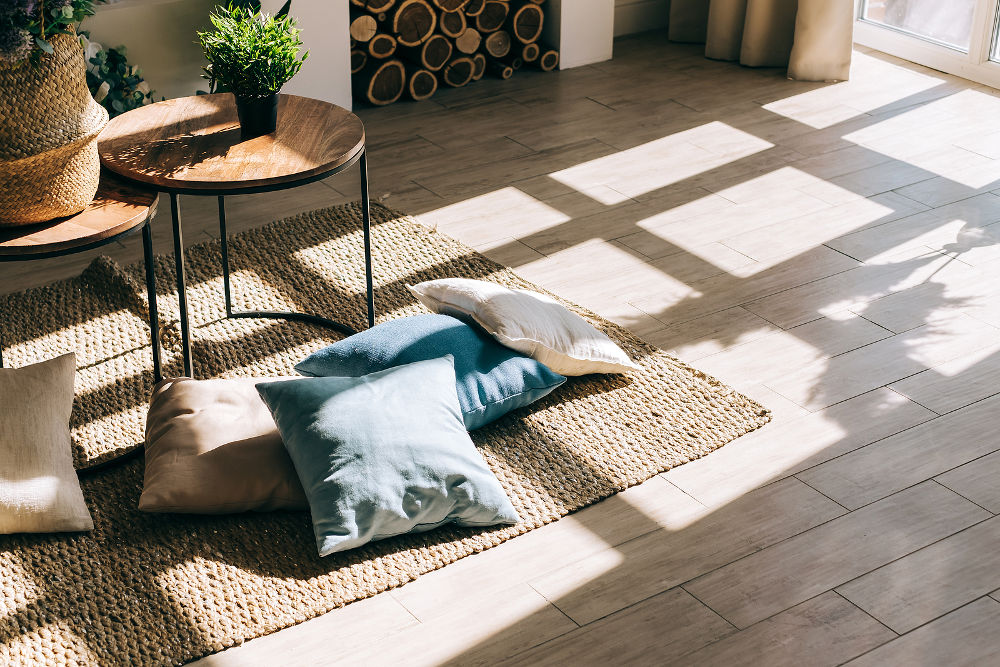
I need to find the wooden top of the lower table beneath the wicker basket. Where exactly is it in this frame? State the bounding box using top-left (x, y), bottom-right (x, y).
top-left (0, 171), bottom-right (158, 260)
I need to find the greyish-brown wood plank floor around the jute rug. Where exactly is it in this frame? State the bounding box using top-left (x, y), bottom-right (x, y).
top-left (9, 33), bottom-right (1000, 666)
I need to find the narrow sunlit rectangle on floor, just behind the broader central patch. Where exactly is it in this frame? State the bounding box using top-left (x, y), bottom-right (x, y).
top-left (549, 121), bottom-right (774, 206)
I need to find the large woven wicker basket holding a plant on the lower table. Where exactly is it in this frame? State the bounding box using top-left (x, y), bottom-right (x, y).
top-left (0, 0), bottom-right (108, 226)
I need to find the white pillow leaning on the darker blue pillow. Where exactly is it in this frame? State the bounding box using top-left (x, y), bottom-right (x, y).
top-left (407, 278), bottom-right (638, 375)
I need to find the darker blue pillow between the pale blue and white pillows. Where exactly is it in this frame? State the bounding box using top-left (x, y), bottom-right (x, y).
top-left (295, 315), bottom-right (566, 431)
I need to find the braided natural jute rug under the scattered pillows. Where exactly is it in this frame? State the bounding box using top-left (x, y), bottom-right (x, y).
top-left (0, 206), bottom-right (769, 665)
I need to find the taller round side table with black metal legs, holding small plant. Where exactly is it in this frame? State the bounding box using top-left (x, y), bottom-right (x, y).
top-left (99, 93), bottom-right (375, 377)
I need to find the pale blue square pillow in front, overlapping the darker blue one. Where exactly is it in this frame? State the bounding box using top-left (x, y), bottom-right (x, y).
top-left (257, 356), bottom-right (520, 556)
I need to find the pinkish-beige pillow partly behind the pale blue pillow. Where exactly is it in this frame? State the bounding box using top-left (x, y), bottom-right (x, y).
top-left (139, 378), bottom-right (309, 514)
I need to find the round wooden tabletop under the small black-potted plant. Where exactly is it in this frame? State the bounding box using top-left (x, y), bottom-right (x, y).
top-left (99, 93), bottom-right (365, 194)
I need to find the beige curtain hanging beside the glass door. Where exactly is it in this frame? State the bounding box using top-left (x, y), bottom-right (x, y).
top-left (669, 0), bottom-right (854, 81)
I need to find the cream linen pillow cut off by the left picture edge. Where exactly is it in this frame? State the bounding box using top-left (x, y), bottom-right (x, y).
top-left (0, 354), bottom-right (94, 534)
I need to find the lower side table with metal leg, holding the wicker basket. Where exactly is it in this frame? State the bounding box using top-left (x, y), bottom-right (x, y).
top-left (0, 171), bottom-right (163, 382)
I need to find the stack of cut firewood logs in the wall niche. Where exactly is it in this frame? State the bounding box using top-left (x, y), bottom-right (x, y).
top-left (350, 0), bottom-right (559, 106)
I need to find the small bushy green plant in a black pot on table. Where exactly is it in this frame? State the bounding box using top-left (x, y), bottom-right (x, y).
top-left (198, 4), bottom-right (309, 139)
